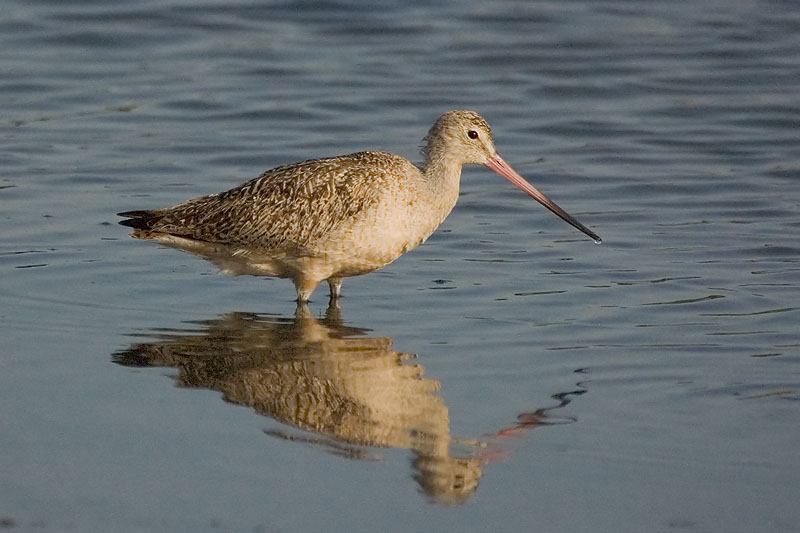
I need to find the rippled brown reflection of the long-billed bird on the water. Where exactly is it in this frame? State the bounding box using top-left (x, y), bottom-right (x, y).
top-left (113, 306), bottom-right (584, 505)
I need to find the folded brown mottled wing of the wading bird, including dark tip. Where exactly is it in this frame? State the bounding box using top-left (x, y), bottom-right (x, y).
top-left (121, 152), bottom-right (418, 249)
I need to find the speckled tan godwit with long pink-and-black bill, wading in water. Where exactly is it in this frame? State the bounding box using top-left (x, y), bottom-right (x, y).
top-left (119, 111), bottom-right (600, 303)
